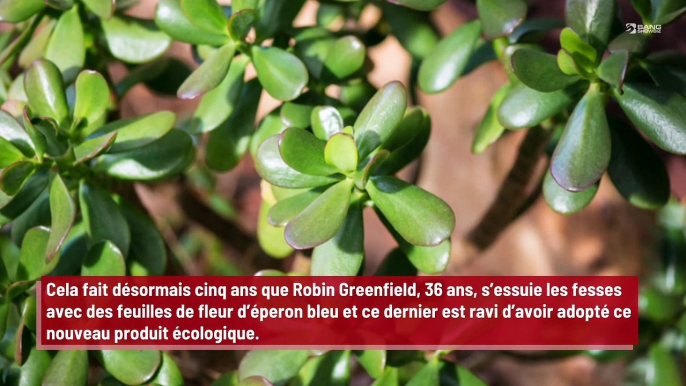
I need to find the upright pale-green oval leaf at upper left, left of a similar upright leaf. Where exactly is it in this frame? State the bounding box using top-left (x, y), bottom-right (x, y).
top-left (24, 59), bottom-right (69, 125)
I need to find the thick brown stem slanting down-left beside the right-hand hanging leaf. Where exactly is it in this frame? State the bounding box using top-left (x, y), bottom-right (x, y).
top-left (464, 126), bottom-right (552, 254)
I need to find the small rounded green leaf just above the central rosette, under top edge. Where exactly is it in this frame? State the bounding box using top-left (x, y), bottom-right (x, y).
top-left (324, 36), bottom-right (367, 81)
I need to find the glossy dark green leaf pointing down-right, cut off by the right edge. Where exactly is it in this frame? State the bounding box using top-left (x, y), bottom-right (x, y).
top-left (615, 83), bottom-right (686, 154)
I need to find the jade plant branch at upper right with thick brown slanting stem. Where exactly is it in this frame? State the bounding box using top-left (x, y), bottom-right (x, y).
top-left (418, 0), bottom-right (686, 251)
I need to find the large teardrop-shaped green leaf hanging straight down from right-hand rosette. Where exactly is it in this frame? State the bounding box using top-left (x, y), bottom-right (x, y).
top-left (550, 88), bottom-right (611, 192)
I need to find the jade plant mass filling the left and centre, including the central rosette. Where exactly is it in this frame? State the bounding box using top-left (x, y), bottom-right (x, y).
top-left (0, 0), bottom-right (482, 385)
